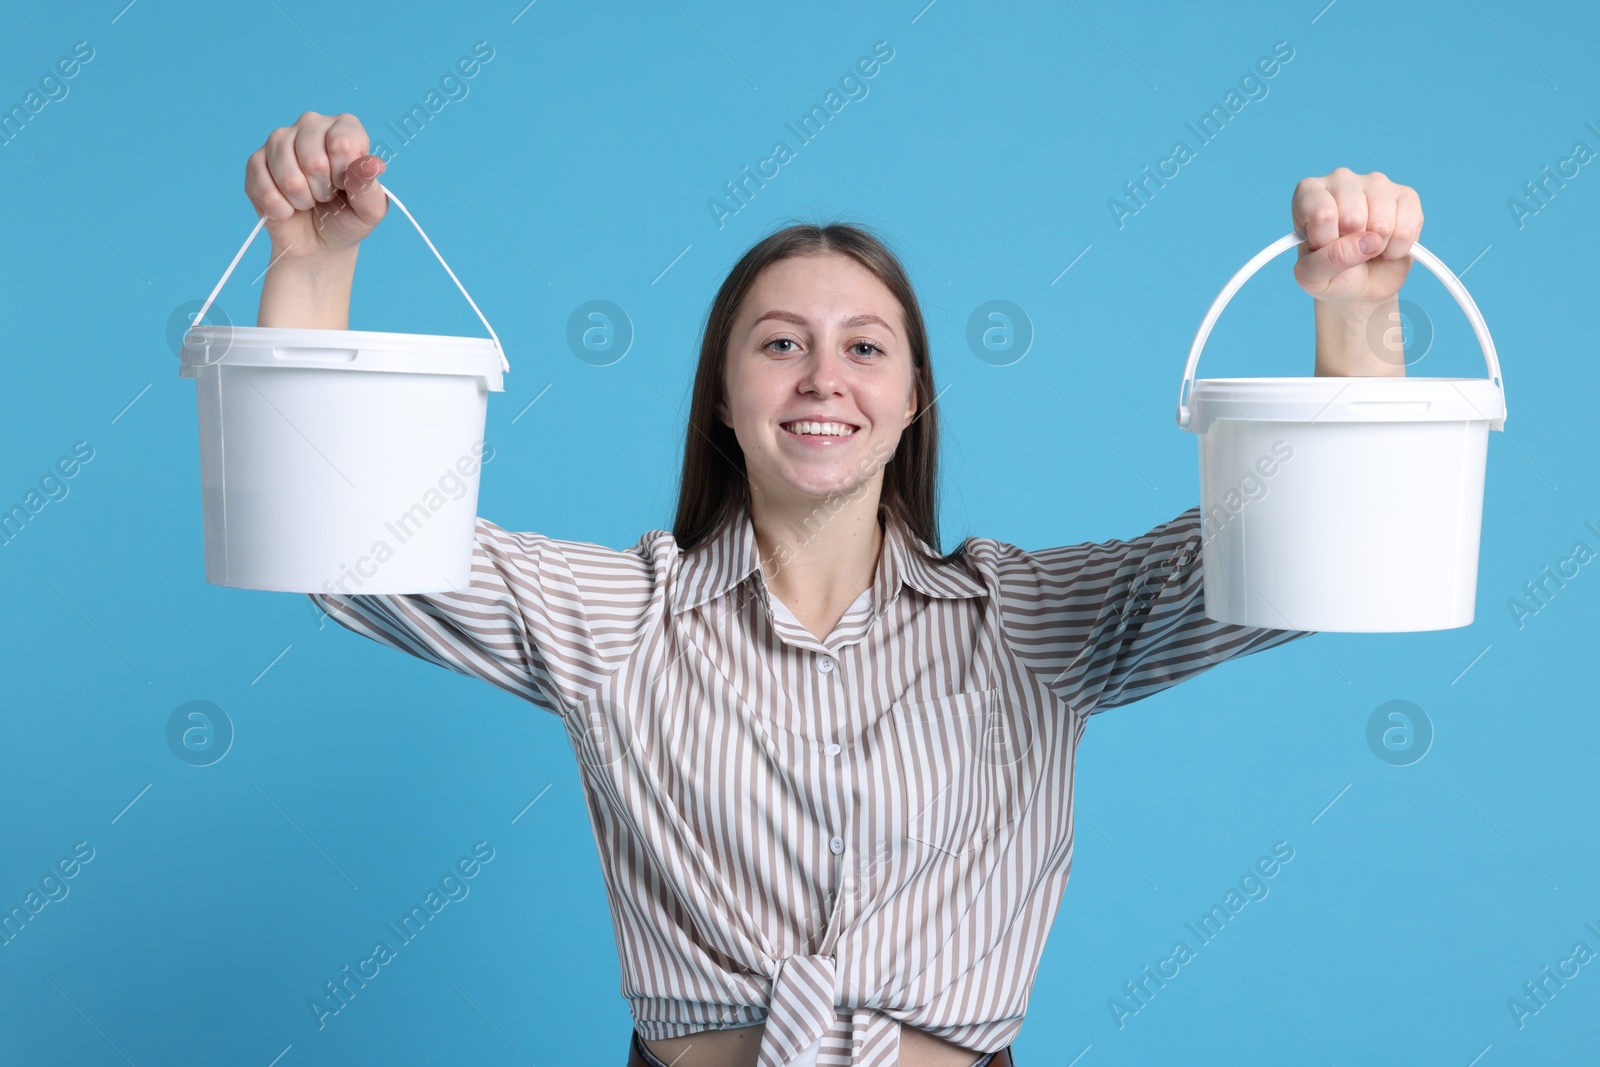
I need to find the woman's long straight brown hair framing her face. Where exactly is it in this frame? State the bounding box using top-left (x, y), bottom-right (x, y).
top-left (672, 222), bottom-right (962, 560)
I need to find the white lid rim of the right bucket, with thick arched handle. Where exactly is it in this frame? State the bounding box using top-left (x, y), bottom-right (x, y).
top-left (1187, 376), bottom-right (1506, 434)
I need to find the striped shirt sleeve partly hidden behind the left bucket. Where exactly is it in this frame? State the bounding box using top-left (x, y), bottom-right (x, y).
top-left (307, 517), bottom-right (672, 715)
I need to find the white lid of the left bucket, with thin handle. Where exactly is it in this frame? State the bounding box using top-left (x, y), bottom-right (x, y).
top-left (178, 326), bottom-right (504, 392)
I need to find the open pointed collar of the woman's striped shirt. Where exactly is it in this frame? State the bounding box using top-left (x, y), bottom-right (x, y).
top-left (672, 506), bottom-right (989, 614)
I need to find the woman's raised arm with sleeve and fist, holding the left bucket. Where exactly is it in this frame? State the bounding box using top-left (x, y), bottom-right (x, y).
top-left (236, 110), bottom-right (675, 715)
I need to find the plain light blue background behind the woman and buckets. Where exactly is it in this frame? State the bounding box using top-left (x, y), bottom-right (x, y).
top-left (0, 0), bottom-right (1600, 1067)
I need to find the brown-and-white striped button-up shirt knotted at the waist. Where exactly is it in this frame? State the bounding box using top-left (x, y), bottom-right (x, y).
top-left (310, 507), bottom-right (1307, 1067)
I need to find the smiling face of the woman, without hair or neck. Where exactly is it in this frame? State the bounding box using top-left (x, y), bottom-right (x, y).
top-left (717, 253), bottom-right (917, 507)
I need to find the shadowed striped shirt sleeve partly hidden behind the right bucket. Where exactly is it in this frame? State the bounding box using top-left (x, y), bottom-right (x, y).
top-left (997, 507), bottom-right (1315, 713)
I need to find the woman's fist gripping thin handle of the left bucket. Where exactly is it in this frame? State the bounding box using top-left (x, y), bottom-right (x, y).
top-left (245, 110), bottom-right (389, 261)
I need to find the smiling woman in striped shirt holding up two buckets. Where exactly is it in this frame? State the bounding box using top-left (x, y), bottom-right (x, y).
top-left (245, 112), bottom-right (1422, 1067)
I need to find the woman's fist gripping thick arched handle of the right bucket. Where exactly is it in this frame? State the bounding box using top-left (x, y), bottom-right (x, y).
top-left (1290, 166), bottom-right (1422, 306)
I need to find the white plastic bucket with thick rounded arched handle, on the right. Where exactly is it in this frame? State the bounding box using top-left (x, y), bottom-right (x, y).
top-left (1178, 234), bottom-right (1506, 633)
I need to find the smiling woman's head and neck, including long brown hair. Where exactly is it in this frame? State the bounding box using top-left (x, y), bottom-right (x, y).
top-left (674, 226), bottom-right (939, 633)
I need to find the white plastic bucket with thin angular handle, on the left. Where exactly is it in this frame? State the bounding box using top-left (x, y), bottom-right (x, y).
top-left (178, 189), bottom-right (510, 593)
